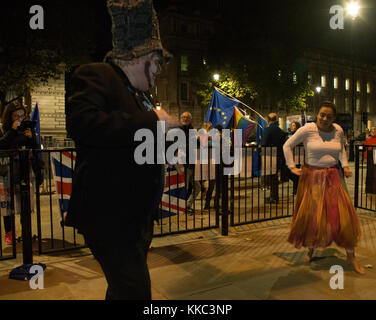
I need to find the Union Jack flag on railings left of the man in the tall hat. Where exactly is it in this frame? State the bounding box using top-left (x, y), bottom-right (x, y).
top-left (51, 152), bottom-right (76, 221)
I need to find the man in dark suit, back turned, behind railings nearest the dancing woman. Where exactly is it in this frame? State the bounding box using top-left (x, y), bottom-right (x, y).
top-left (262, 113), bottom-right (287, 203)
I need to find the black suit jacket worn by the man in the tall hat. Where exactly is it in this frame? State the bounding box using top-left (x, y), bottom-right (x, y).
top-left (66, 63), bottom-right (164, 238)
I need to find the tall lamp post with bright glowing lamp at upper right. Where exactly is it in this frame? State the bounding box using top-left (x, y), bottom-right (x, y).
top-left (346, 2), bottom-right (360, 161)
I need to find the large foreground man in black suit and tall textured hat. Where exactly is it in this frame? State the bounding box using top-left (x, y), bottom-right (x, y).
top-left (65, 0), bottom-right (178, 300)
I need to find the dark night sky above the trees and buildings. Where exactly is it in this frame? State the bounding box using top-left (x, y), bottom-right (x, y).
top-left (2, 0), bottom-right (376, 63)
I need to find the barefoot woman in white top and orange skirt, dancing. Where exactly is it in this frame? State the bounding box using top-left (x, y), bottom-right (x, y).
top-left (283, 102), bottom-right (365, 274)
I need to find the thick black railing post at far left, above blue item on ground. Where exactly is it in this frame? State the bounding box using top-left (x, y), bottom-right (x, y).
top-left (16, 150), bottom-right (33, 264)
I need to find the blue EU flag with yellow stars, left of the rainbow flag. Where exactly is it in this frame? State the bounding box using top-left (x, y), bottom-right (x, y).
top-left (204, 89), bottom-right (239, 128)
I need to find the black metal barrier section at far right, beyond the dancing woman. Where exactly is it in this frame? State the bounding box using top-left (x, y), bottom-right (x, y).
top-left (354, 145), bottom-right (376, 212)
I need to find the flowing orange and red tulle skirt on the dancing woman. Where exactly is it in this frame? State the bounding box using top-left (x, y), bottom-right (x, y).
top-left (288, 165), bottom-right (360, 249)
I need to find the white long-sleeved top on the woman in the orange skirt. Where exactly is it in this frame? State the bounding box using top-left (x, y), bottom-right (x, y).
top-left (283, 122), bottom-right (348, 168)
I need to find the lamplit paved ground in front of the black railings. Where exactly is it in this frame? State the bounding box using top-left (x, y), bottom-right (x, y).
top-left (0, 214), bottom-right (376, 300)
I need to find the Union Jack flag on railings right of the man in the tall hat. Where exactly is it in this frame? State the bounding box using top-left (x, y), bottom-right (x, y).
top-left (161, 166), bottom-right (186, 218)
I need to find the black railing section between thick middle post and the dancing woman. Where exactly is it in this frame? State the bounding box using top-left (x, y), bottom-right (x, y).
top-left (230, 146), bottom-right (304, 226)
